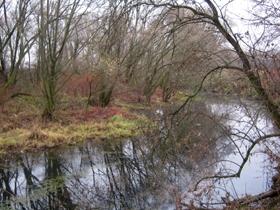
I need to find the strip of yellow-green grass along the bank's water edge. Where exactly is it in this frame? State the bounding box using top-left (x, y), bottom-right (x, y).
top-left (0, 115), bottom-right (153, 152)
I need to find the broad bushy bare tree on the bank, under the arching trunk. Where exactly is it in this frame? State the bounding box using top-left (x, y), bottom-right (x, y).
top-left (130, 9), bottom-right (221, 102)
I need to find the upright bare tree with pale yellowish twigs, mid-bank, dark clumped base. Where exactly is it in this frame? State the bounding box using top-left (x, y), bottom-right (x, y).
top-left (89, 1), bottom-right (144, 107)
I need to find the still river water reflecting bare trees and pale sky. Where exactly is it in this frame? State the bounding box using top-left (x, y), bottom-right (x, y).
top-left (0, 99), bottom-right (277, 209)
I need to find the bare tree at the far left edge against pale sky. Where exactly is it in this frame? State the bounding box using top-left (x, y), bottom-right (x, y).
top-left (0, 0), bottom-right (38, 101)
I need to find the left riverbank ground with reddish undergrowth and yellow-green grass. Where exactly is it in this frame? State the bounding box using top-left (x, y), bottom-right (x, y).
top-left (0, 97), bottom-right (154, 155)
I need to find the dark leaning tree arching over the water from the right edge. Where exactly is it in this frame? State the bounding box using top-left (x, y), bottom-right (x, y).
top-left (125, 0), bottom-right (280, 125)
